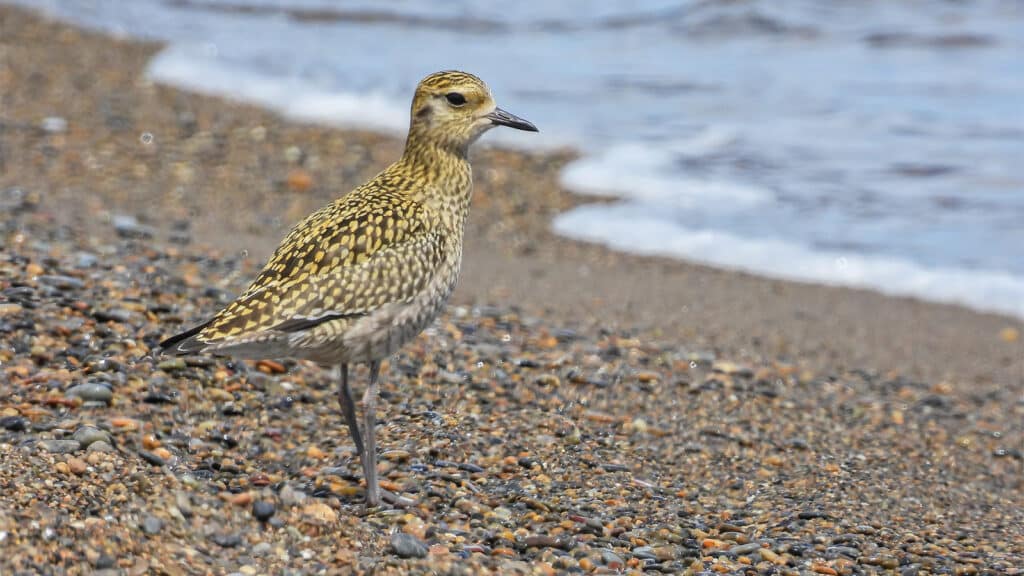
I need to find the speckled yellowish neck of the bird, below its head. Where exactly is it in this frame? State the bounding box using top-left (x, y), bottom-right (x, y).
top-left (397, 134), bottom-right (473, 236)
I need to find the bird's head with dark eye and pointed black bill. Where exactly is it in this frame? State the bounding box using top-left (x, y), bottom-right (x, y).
top-left (410, 71), bottom-right (538, 153)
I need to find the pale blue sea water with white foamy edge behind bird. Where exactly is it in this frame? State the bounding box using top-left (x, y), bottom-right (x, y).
top-left (19, 0), bottom-right (1024, 317)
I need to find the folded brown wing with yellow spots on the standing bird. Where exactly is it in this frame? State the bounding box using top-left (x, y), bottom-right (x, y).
top-left (161, 194), bottom-right (449, 353)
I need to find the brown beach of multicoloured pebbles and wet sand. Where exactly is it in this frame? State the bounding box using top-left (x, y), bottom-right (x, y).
top-left (0, 6), bottom-right (1024, 576)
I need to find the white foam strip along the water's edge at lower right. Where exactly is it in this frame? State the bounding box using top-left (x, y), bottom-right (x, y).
top-left (553, 203), bottom-right (1024, 319)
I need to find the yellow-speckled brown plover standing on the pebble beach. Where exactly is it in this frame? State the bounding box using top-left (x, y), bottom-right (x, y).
top-left (160, 70), bottom-right (538, 507)
